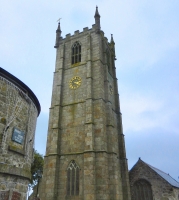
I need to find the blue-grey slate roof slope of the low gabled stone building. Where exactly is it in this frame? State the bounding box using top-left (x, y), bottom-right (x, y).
top-left (142, 161), bottom-right (179, 188)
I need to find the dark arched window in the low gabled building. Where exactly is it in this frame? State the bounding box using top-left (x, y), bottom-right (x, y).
top-left (132, 179), bottom-right (153, 200)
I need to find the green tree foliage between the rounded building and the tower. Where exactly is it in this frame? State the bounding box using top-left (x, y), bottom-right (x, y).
top-left (29, 150), bottom-right (44, 188)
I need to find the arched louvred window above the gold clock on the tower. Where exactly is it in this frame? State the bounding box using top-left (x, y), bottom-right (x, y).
top-left (71, 42), bottom-right (81, 65)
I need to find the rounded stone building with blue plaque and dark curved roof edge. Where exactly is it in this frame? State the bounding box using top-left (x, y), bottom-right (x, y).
top-left (0, 68), bottom-right (40, 200)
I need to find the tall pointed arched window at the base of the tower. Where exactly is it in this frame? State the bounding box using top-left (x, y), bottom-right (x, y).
top-left (67, 160), bottom-right (80, 196)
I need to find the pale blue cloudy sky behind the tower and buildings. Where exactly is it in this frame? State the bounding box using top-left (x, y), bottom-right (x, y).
top-left (0, 0), bottom-right (179, 181)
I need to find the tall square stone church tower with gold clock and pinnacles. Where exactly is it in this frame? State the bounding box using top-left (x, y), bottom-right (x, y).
top-left (40, 7), bottom-right (130, 200)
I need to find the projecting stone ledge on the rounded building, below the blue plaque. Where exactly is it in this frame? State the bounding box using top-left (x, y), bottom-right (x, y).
top-left (0, 163), bottom-right (31, 180)
